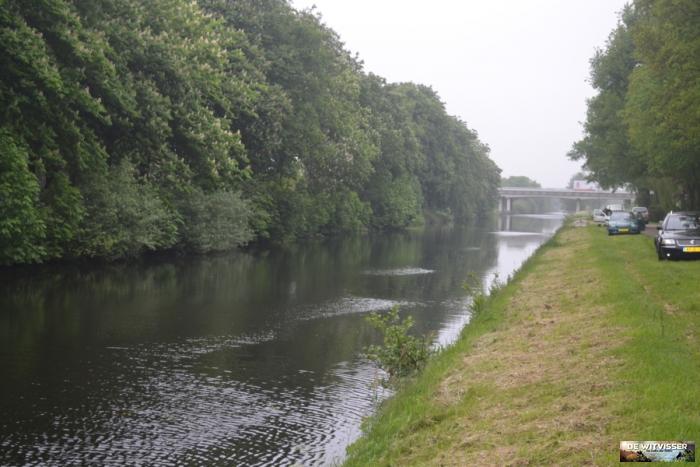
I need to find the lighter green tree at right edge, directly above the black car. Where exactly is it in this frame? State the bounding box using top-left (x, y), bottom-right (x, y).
top-left (624, 0), bottom-right (700, 208)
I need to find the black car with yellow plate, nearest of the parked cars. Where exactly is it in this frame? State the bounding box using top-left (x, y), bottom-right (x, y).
top-left (654, 212), bottom-right (700, 260)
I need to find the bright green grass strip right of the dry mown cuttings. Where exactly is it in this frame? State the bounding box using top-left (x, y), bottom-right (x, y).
top-left (590, 232), bottom-right (700, 441)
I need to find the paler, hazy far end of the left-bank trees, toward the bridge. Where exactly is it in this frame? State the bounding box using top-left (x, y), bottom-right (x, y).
top-left (362, 75), bottom-right (500, 228)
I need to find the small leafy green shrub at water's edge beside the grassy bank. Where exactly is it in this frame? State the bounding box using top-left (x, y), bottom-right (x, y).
top-left (366, 306), bottom-right (434, 381)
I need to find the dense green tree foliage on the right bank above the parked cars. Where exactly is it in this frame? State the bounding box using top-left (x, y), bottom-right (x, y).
top-left (570, 0), bottom-right (700, 208)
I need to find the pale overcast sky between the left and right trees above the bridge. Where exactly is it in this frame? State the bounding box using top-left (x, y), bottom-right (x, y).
top-left (292, 0), bottom-right (626, 187)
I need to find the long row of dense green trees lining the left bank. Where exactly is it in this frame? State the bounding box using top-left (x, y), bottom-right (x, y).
top-left (0, 0), bottom-right (499, 264)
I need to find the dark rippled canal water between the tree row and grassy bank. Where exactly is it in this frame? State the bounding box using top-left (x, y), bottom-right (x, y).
top-left (0, 214), bottom-right (562, 465)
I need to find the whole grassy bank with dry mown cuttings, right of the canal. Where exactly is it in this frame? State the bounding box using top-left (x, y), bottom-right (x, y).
top-left (347, 221), bottom-right (700, 466)
